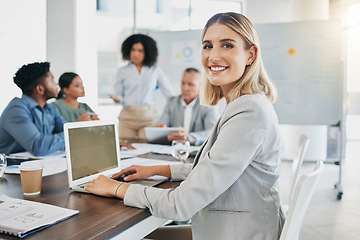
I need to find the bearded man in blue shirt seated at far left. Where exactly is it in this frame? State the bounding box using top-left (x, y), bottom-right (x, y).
top-left (0, 62), bottom-right (65, 156)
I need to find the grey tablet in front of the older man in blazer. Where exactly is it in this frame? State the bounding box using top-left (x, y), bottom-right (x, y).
top-left (144, 127), bottom-right (181, 145)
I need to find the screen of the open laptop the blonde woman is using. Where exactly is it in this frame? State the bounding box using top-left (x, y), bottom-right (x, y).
top-left (68, 124), bottom-right (119, 180)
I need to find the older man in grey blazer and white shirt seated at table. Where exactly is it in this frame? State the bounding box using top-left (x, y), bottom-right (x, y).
top-left (156, 68), bottom-right (217, 145)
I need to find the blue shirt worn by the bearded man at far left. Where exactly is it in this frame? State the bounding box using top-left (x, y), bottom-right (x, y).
top-left (0, 95), bottom-right (65, 156)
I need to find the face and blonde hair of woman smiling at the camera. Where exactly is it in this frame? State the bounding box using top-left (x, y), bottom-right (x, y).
top-left (200, 13), bottom-right (276, 105)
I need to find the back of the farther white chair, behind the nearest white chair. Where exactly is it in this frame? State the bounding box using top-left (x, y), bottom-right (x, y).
top-left (282, 134), bottom-right (310, 215)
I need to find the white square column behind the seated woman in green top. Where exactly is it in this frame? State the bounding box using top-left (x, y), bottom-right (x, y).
top-left (47, 0), bottom-right (98, 111)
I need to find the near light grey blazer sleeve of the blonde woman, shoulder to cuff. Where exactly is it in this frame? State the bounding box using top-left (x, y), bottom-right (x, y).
top-left (124, 99), bottom-right (267, 221)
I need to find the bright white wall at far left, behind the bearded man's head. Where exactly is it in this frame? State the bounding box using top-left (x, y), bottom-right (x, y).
top-left (0, 0), bottom-right (46, 113)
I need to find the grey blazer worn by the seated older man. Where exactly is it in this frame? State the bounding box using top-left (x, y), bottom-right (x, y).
top-left (157, 95), bottom-right (218, 145)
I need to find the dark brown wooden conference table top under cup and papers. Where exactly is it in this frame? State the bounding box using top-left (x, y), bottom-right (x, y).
top-left (0, 143), bottom-right (191, 240)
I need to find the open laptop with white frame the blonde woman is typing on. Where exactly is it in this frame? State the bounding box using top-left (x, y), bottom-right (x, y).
top-left (64, 120), bottom-right (166, 192)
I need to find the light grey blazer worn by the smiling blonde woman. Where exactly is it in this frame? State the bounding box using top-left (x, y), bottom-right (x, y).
top-left (124, 94), bottom-right (284, 240)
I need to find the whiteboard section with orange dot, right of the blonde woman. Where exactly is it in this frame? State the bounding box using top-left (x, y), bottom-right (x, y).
top-left (255, 21), bottom-right (343, 125)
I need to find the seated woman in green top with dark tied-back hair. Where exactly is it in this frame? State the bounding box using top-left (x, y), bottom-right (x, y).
top-left (52, 72), bottom-right (99, 122)
